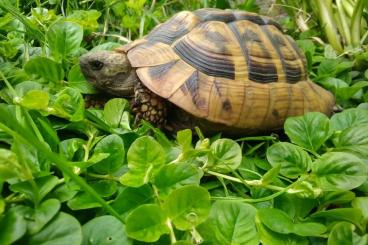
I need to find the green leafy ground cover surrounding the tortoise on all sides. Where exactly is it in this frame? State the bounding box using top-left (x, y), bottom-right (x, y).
top-left (0, 0), bottom-right (368, 245)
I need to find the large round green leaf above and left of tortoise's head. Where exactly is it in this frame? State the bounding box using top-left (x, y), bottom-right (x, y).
top-left (46, 21), bottom-right (83, 60)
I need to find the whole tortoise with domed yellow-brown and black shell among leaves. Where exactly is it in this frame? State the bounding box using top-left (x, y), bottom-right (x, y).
top-left (80, 9), bottom-right (334, 134)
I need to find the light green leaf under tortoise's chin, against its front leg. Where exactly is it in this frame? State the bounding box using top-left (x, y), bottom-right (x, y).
top-left (104, 98), bottom-right (130, 130)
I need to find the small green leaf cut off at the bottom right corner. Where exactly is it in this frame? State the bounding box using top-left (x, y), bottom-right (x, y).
top-left (327, 222), bottom-right (368, 245)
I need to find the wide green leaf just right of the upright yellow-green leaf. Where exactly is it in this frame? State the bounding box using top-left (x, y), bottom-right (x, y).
top-left (153, 163), bottom-right (203, 196)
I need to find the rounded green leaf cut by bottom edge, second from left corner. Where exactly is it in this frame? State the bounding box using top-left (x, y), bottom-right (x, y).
top-left (28, 212), bottom-right (82, 245)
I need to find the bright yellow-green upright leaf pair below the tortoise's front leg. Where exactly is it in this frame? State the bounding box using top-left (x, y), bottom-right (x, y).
top-left (120, 136), bottom-right (165, 187)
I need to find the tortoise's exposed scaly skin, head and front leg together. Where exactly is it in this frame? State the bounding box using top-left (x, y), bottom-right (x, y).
top-left (80, 51), bottom-right (166, 128)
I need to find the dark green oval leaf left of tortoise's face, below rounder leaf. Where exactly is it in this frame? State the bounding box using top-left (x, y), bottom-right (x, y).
top-left (24, 57), bottom-right (64, 83)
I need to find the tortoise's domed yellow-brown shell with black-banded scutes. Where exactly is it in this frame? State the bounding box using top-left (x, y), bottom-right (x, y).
top-left (120, 9), bottom-right (334, 130)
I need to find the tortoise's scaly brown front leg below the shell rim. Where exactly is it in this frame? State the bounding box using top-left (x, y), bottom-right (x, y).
top-left (132, 82), bottom-right (167, 128)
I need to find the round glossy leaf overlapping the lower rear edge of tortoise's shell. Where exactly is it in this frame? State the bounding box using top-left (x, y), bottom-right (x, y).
top-left (284, 112), bottom-right (330, 151)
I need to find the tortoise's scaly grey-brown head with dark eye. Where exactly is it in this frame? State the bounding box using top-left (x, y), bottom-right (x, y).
top-left (79, 51), bottom-right (137, 97)
